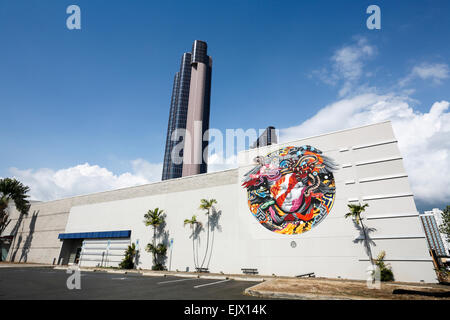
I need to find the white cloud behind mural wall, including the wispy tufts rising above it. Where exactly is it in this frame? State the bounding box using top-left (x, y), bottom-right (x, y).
top-left (304, 38), bottom-right (450, 204)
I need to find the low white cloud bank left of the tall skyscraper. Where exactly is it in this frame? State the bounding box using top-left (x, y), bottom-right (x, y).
top-left (10, 159), bottom-right (162, 201)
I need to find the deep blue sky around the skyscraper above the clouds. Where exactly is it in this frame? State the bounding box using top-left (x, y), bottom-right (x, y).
top-left (0, 0), bottom-right (450, 211)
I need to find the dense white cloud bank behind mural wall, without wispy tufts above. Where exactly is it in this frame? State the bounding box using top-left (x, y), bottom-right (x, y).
top-left (280, 93), bottom-right (450, 204)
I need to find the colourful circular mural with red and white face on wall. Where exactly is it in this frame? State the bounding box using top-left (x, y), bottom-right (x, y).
top-left (242, 146), bottom-right (338, 234)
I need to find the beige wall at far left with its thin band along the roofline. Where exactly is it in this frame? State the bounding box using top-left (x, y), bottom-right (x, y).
top-left (1, 170), bottom-right (237, 264)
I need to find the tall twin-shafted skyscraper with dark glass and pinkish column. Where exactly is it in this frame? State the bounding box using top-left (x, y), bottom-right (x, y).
top-left (162, 40), bottom-right (212, 180)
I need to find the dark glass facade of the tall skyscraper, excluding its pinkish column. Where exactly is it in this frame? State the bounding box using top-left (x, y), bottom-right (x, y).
top-left (162, 40), bottom-right (211, 180)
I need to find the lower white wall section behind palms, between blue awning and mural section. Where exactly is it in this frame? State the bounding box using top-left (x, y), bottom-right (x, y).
top-left (66, 184), bottom-right (240, 273)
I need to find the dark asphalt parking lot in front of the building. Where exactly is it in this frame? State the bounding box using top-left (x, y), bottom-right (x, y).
top-left (0, 267), bottom-right (257, 300)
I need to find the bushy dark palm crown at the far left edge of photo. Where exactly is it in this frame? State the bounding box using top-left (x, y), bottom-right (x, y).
top-left (0, 178), bottom-right (30, 233)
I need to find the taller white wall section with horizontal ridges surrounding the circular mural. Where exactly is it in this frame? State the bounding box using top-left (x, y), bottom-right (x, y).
top-left (238, 122), bottom-right (436, 282)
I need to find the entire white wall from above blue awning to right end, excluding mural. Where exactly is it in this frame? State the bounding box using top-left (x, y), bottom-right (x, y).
top-left (59, 122), bottom-right (436, 282)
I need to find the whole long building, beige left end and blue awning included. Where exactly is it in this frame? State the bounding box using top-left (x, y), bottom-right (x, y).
top-left (3, 122), bottom-right (436, 282)
